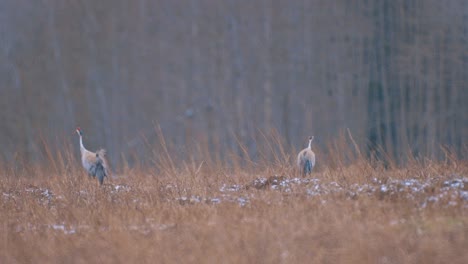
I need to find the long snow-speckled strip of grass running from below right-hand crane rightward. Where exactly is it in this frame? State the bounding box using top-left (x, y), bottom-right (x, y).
top-left (211, 175), bottom-right (468, 208)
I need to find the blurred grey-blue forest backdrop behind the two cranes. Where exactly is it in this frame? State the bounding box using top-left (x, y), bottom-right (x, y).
top-left (0, 0), bottom-right (468, 167)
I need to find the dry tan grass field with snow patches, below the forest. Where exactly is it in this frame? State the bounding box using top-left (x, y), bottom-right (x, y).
top-left (0, 137), bottom-right (468, 263)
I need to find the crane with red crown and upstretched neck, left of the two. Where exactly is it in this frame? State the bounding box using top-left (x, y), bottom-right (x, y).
top-left (76, 127), bottom-right (109, 185)
